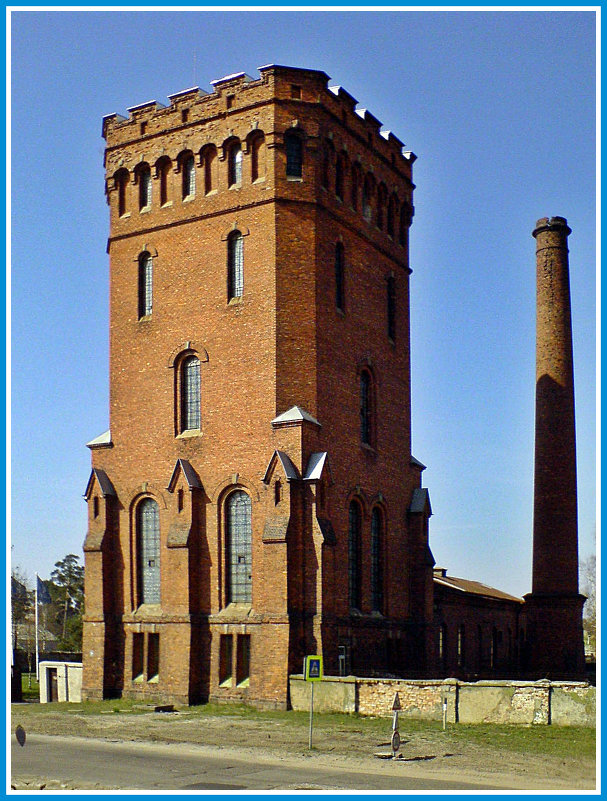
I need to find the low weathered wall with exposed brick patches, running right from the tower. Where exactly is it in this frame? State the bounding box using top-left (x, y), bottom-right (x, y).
top-left (289, 675), bottom-right (596, 727)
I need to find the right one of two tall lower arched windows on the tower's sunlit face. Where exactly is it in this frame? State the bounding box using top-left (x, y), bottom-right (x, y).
top-left (225, 490), bottom-right (252, 603)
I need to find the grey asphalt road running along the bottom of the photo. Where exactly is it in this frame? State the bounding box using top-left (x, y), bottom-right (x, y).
top-left (11, 734), bottom-right (506, 792)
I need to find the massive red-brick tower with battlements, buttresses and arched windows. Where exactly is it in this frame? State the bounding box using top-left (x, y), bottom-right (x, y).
top-left (82, 65), bottom-right (588, 706)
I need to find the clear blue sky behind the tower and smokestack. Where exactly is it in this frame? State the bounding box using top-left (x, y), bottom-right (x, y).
top-left (11, 9), bottom-right (596, 595)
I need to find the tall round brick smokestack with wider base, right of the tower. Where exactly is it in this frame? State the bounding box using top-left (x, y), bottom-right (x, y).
top-left (525, 217), bottom-right (584, 678)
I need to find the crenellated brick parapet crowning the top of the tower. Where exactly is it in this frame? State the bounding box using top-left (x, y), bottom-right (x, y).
top-left (102, 64), bottom-right (415, 167)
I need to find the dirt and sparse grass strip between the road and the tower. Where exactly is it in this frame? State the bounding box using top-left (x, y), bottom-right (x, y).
top-left (12, 704), bottom-right (596, 791)
